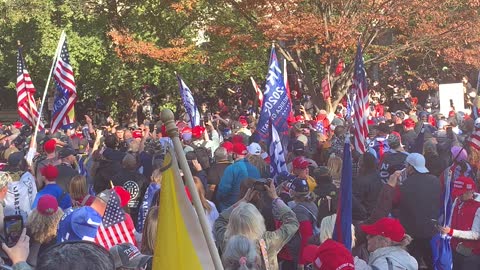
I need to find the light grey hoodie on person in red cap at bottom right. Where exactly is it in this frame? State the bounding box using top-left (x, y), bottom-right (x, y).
top-left (368, 246), bottom-right (418, 270)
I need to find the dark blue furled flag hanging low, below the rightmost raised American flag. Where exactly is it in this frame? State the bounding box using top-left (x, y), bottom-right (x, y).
top-left (333, 136), bottom-right (352, 250)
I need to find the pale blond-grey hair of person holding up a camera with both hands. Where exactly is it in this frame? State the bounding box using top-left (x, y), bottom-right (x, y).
top-left (224, 202), bottom-right (267, 241)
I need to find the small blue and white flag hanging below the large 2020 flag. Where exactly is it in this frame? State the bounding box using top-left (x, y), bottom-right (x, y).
top-left (268, 123), bottom-right (288, 179)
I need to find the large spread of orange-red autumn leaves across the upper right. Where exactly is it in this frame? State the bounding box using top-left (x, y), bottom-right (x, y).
top-left (209, 0), bottom-right (480, 68)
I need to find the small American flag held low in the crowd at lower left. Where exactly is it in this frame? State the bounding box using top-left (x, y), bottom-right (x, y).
top-left (95, 189), bottom-right (137, 250)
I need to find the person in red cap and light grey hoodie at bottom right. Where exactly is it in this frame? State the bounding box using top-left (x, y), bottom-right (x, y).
top-left (360, 218), bottom-right (418, 270)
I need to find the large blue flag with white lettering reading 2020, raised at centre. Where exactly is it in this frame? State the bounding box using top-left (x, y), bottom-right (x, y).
top-left (257, 46), bottom-right (291, 140)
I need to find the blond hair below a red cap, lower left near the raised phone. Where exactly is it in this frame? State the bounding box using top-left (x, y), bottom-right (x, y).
top-left (27, 208), bottom-right (63, 244)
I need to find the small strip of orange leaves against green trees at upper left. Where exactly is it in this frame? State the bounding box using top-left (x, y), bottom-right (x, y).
top-left (108, 30), bottom-right (193, 63)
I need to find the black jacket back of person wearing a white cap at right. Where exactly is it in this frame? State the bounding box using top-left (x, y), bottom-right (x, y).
top-left (398, 173), bottom-right (441, 238)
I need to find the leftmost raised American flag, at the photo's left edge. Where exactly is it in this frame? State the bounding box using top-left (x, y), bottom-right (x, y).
top-left (16, 48), bottom-right (43, 128)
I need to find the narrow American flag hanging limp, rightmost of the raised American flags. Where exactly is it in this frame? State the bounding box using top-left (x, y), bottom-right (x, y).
top-left (351, 42), bottom-right (369, 154)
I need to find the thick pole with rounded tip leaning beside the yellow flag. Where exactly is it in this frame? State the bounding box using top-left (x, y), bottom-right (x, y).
top-left (160, 109), bottom-right (223, 270)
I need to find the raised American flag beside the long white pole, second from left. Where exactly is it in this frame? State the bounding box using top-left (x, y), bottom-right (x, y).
top-left (51, 35), bottom-right (77, 133)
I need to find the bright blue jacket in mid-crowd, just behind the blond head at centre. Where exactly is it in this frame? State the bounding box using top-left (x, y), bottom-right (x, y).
top-left (217, 159), bottom-right (260, 212)
